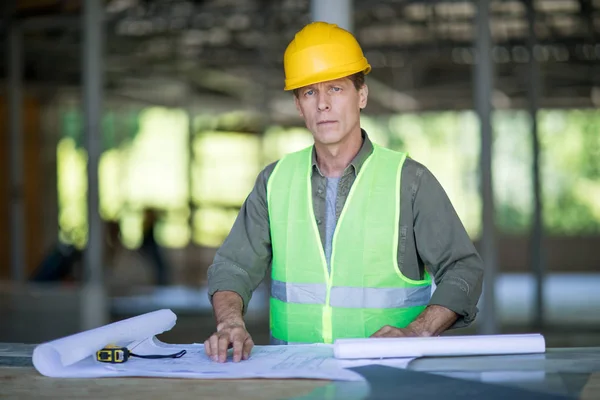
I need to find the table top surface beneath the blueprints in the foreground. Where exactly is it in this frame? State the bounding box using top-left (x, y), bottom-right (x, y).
top-left (0, 343), bottom-right (600, 400)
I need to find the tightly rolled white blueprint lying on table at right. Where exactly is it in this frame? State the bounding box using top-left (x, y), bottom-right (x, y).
top-left (333, 334), bottom-right (546, 359)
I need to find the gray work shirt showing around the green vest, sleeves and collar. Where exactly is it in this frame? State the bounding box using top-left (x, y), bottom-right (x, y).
top-left (208, 131), bottom-right (483, 328)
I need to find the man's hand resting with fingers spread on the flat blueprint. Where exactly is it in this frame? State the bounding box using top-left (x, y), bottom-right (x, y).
top-left (204, 321), bottom-right (254, 363)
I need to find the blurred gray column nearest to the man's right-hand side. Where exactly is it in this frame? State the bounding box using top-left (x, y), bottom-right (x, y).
top-left (474, 0), bottom-right (497, 334)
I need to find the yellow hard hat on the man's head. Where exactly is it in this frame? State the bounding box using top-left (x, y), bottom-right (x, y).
top-left (283, 22), bottom-right (371, 90)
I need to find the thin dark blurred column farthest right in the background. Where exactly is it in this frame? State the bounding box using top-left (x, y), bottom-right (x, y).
top-left (525, 0), bottom-right (545, 330)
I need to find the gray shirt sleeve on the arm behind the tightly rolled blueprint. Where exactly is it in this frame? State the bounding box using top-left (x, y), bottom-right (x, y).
top-left (413, 168), bottom-right (484, 328)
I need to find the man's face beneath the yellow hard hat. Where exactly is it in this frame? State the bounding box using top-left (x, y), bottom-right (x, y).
top-left (296, 78), bottom-right (368, 144)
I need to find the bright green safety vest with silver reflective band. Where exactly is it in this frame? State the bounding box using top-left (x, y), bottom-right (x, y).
top-left (267, 145), bottom-right (431, 344)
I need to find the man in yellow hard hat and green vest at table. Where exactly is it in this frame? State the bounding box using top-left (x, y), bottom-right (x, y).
top-left (205, 22), bottom-right (483, 362)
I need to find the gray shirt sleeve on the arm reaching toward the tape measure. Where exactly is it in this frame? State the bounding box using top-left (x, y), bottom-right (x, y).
top-left (208, 164), bottom-right (275, 314)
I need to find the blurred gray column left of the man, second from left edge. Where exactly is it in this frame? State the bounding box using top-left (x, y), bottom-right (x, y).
top-left (81, 0), bottom-right (108, 329)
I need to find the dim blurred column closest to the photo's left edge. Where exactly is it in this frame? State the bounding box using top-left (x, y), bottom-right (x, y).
top-left (7, 8), bottom-right (25, 283)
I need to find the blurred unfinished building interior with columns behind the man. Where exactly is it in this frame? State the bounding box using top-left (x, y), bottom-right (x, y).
top-left (0, 0), bottom-right (600, 347)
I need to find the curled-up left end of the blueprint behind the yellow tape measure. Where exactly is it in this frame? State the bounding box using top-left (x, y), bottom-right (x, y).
top-left (33, 310), bottom-right (177, 377)
